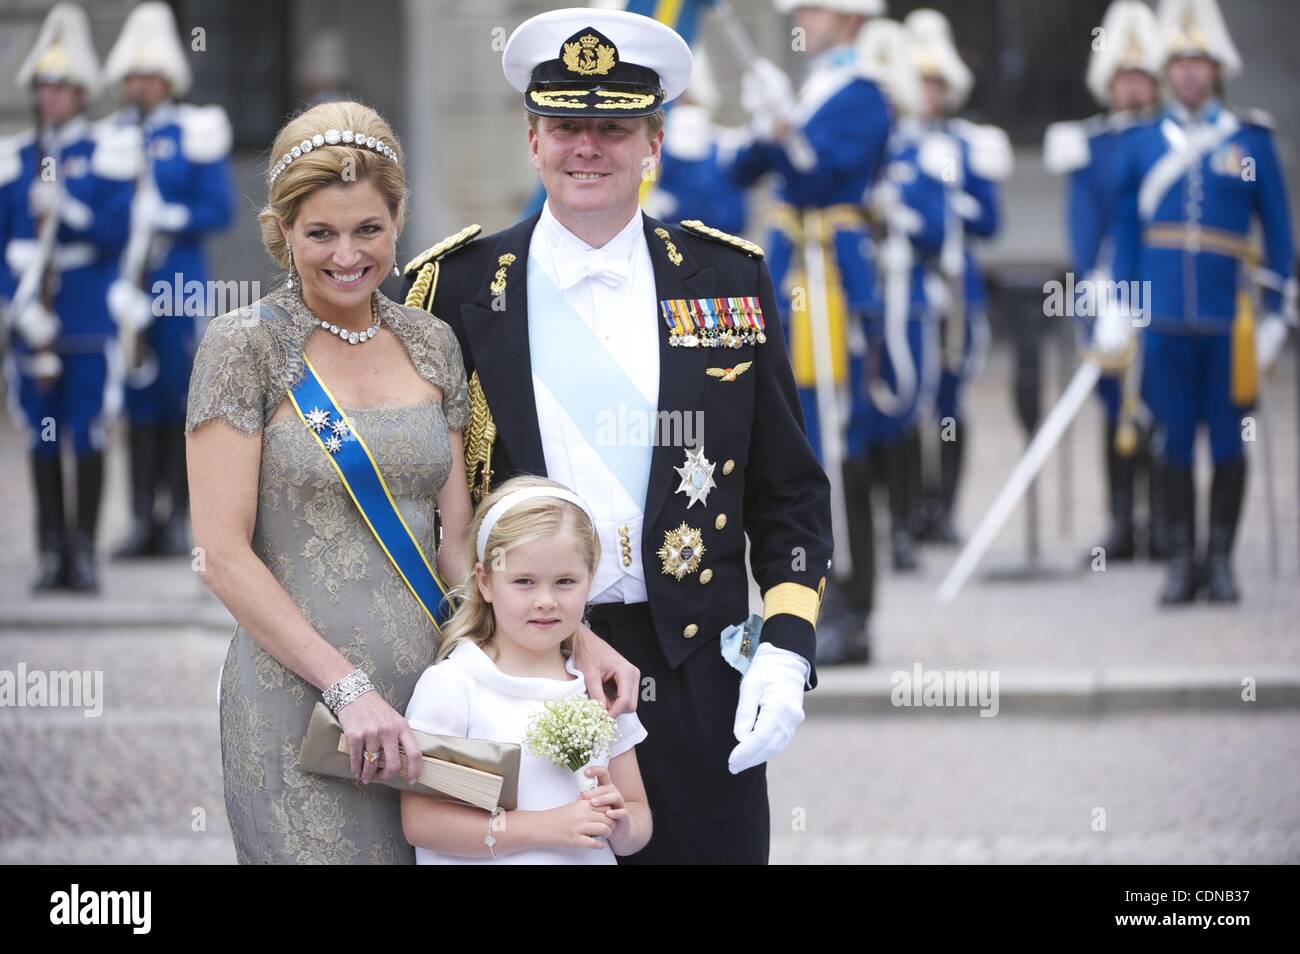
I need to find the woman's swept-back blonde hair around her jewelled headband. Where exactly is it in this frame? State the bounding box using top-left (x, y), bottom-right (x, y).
top-left (257, 101), bottom-right (407, 268)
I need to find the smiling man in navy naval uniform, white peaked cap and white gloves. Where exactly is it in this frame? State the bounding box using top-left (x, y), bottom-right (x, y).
top-left (407, 9), bottom-right (831, 863)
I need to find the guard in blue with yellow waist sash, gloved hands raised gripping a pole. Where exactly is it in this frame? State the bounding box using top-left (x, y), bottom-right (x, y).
top-left (732, 0), bottom-right (891, 664)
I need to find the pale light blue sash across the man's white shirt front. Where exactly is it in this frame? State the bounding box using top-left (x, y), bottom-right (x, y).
top-left (528, 259), bottom-right (658, 507)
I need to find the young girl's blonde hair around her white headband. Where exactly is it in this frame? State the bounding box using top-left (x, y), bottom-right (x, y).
top-left (434, 476), bottom-right (601, 663)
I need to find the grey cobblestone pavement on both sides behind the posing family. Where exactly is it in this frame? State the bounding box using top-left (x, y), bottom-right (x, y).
top-left (0, 355), bottom-right (1300, 863)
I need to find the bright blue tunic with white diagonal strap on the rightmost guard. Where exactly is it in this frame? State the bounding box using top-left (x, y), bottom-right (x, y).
top-left (1112, 101), bottom-right (1295, 334)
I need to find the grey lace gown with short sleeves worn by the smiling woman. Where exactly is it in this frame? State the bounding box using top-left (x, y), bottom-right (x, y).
top-left (186, 290), bottom-right (468, 864)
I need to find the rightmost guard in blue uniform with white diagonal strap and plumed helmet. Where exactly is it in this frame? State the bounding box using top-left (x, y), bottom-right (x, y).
top-left (1113, 0), bottom-right (1296, 604)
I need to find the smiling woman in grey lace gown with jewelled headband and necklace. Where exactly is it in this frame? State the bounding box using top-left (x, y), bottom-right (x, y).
top-left (186, 103), bottom-right (471, 864)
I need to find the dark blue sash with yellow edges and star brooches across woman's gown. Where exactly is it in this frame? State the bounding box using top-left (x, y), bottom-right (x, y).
top-left (289, 354), bottom-right (452, 637)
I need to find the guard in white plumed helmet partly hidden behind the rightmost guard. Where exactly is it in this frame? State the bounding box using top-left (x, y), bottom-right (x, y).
top-left (1043, 0), bottom-right (1167, 560)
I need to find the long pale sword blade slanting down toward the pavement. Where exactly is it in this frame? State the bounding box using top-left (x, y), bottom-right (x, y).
top-left (936, 359), bottom-right (1101, 604)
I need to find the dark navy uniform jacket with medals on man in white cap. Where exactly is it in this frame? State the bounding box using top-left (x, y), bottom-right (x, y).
top-left (407, 216), bottom-right (831, 686)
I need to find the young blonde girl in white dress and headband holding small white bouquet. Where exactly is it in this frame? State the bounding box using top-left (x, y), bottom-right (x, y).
top-left (402, 477), bottom-right (650, 864)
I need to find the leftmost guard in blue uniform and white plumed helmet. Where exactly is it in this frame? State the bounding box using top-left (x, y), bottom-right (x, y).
top-left (0, 4), bottom-right (133, 591)
